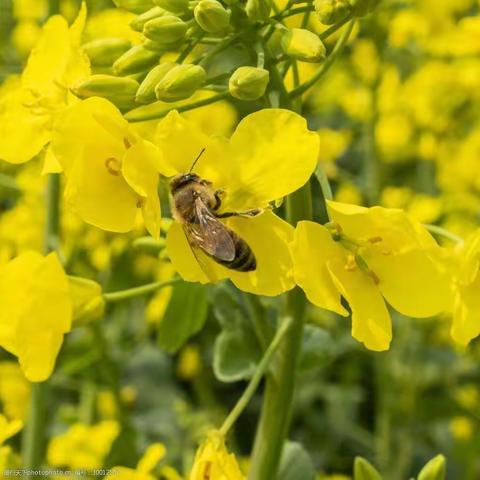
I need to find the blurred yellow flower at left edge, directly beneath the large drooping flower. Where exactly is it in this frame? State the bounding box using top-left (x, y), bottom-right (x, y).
top-left (0, 361), bottom-right (30, 420)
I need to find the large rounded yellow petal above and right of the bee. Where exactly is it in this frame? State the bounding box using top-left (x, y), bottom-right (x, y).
top-left (225, 109), bottom-right (319, 210)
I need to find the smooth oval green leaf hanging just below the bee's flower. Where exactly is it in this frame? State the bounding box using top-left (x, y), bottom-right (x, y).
top-left (158, 282), bottom-right (208, 353)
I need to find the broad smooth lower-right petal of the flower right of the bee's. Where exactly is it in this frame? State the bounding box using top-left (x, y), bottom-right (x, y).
top-left (366, 250), bottom-right (453, 318)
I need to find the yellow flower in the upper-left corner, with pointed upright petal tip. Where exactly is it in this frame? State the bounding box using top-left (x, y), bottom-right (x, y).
top-left (0, 5), bottom-right (90, 165)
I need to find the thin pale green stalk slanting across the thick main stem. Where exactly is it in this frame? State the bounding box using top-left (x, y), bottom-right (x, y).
top-left (220, 318), bottom-right (292, 436)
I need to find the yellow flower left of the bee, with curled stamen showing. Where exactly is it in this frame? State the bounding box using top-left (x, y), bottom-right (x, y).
top-left (52, 97), bottom-right (170, 237)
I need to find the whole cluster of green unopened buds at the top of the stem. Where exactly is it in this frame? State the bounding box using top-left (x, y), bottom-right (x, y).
top-left (72, 0), bottom-right (380, 110)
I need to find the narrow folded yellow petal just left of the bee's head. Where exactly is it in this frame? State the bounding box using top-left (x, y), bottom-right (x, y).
top-left (122, 140), bottom-right (161, 238)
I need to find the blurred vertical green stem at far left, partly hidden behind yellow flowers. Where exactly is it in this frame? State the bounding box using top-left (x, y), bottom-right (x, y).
top-left (22, 174), bottom-right (60, 472)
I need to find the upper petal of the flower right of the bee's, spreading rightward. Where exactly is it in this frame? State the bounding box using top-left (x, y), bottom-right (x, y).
top-left (327, 201), bottom-right (438, 253)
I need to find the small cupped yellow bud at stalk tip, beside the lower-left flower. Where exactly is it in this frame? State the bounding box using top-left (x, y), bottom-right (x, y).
top-left (68, 276), bottom-right (105, 325)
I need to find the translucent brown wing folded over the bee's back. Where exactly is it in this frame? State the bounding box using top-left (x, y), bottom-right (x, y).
top-left (187, 198), bottom-right (235, 262)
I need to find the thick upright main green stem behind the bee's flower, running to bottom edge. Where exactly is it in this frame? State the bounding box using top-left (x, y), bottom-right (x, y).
top-left (249, 184), bottom-right (312, 480)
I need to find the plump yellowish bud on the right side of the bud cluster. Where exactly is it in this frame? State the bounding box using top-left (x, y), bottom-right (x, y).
top-left (280, 28), bottom-right (326, 63)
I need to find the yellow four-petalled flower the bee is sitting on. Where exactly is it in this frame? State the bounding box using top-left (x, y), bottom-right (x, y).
top-left (156, 109), bottom-right (318, 295)
